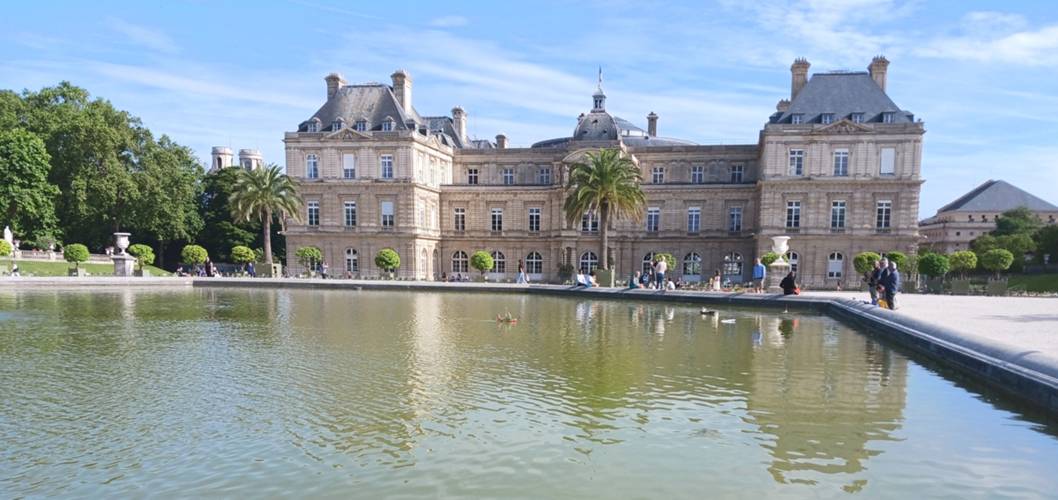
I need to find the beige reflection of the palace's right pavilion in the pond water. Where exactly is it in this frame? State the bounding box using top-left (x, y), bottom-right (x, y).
top-left (747, 317), bottom-right (907, 490)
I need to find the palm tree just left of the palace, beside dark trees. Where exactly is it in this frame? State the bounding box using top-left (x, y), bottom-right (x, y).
top-left (229, 164), bottom-right (304, 273)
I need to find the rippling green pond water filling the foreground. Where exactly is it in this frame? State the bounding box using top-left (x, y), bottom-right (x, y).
top-left (0, 289), bottom-right (1058, 498)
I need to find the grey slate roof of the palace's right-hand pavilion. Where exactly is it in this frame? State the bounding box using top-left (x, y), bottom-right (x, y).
top-left (770, 72), bottom-right (914, 124)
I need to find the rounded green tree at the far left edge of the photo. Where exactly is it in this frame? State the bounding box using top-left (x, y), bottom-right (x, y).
top-left (0, 129), bottom-right (59, 241)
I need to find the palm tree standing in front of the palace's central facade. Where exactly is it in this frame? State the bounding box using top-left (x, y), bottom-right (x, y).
top-left (564, 149), bottom-right (646, 270)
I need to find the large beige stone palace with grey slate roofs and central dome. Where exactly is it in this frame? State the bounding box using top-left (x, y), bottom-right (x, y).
top-left (284, 57), bottom-right (925, 288)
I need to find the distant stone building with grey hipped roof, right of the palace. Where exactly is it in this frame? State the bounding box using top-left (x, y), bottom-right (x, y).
top-left (918, 180), bottom-right (1058, 254)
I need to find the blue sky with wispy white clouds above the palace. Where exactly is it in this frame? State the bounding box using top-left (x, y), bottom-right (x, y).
top-left (0, 0), bottom-right (1058, 216)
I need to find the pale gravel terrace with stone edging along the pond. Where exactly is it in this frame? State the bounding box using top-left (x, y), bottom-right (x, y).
top-left (0, 277), bottom-right (1058, 414)
